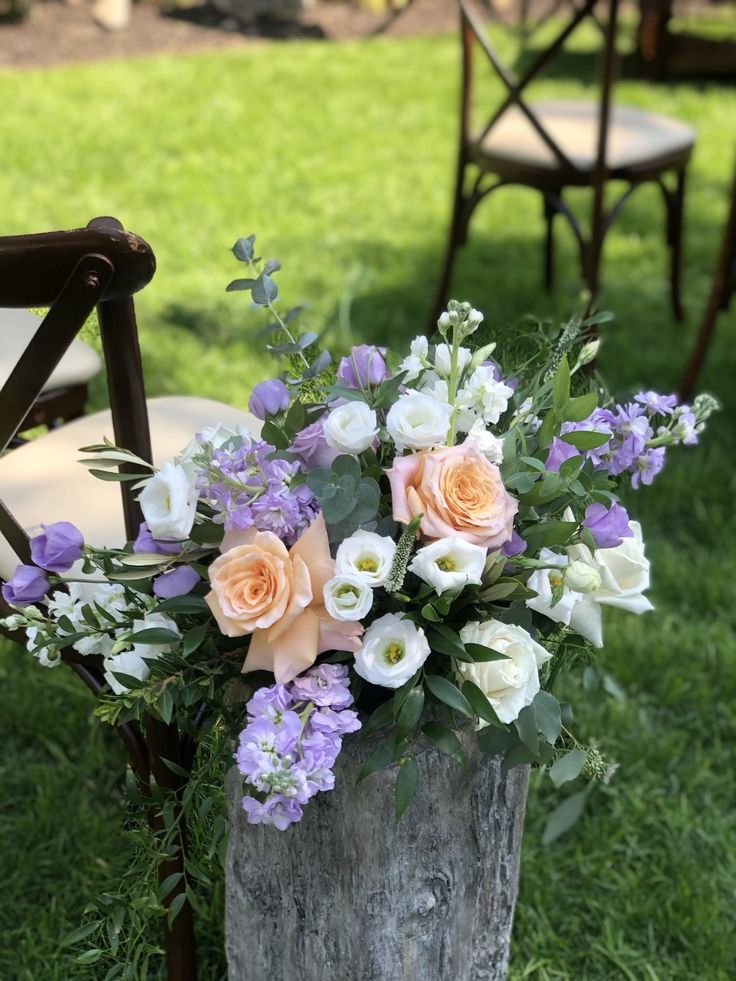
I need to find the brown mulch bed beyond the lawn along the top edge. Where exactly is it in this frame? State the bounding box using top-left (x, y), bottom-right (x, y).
top-left (0, 0), bottom-right (457, 68)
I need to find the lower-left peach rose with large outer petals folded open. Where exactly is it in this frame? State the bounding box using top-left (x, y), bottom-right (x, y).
top-left (207, 515), bottom-right (363, 684)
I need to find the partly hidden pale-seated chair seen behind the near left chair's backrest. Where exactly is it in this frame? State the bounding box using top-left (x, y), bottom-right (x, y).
top-left (0, 308), bottom-right (102, 433)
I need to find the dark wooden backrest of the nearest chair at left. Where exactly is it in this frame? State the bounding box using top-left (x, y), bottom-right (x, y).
top-left (0, 218), bottom-right (156, 580)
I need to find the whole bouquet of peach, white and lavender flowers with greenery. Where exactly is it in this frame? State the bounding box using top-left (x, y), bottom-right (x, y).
top-left (3, 236), bottom-right (716, 830)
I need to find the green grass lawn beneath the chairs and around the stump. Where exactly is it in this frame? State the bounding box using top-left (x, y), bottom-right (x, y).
top-left (0, 24), bottom-right (736, 981)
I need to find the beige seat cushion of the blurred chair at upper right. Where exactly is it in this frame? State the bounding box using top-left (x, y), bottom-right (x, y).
top-left (480, 100), bottom-right (695, 171)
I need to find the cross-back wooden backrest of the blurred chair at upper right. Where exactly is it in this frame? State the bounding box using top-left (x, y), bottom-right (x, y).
top-left (460, 0), bottom-right (619, 185)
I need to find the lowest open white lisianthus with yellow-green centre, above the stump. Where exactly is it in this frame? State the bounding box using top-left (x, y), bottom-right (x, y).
top-left (355, 613), bottom-right (430, 688)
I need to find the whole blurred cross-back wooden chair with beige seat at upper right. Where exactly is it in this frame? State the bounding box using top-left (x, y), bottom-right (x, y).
top-left (433, 0), bottom-right (695, 320)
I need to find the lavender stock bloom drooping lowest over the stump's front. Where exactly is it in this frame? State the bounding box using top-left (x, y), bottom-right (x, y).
top-left (235, 664), bottom-right (360, 831)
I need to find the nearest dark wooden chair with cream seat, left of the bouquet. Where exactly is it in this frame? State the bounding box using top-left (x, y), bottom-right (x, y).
top-left (0, 218), bottom-right (252, 981)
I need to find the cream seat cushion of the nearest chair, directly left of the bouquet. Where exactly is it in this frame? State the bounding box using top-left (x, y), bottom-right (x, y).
top-left (0, 397), bottom-right (261, 579)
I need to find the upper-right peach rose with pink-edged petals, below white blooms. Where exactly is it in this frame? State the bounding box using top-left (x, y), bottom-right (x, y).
top-left (387, 440), bottom-right (519, 548)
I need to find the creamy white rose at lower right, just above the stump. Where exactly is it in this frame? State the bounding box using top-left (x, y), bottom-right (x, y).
top-left (459, 620), bottom-right (551, 728)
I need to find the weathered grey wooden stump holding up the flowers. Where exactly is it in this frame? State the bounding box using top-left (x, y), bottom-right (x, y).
top-left (225, 733), bottom-right (529, 981)
